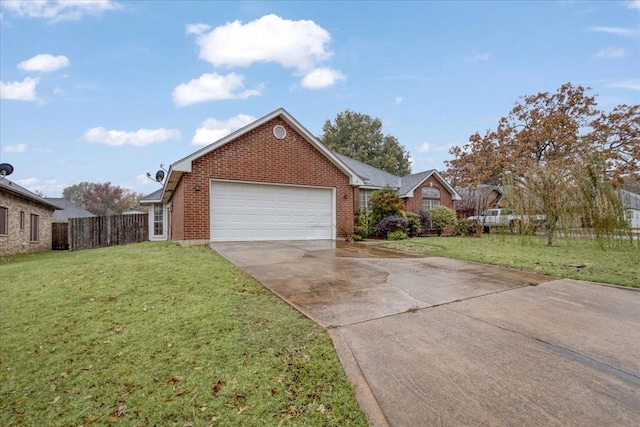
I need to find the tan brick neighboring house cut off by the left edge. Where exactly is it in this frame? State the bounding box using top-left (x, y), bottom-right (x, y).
top-left (0, 178), bottom-right (60, 255)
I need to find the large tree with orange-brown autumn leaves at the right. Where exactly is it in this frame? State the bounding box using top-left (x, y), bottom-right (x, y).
top-left (446, 83), bottom-right (640, 246)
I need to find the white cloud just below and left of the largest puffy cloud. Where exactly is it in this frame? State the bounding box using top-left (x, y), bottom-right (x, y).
top-left (173, 73), bottom-right (261, 107)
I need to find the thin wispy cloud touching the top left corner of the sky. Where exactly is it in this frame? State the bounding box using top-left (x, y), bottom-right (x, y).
top-left (0, 0), bottom-right (122, 23)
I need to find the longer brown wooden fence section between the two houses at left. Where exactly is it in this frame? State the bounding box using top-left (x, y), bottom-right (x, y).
top-left (69, 213), bottom-right (149, 251)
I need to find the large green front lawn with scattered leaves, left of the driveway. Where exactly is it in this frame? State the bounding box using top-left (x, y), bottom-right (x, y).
top-left (0, 243), bottom-right (367, 427)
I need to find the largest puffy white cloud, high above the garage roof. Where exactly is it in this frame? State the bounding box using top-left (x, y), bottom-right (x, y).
top-left (197, 14), bottom-right (331, 72)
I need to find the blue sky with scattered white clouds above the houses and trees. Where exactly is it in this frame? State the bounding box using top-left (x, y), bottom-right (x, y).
top-left (0, 0), bottom-right (640, 197)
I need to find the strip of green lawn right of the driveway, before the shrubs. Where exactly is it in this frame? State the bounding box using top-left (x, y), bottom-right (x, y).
top-left (384, 235), bottom-right (640, 287)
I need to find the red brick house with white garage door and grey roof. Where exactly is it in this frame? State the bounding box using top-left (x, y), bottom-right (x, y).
top-left (140, 108), bottom-right (459, 243)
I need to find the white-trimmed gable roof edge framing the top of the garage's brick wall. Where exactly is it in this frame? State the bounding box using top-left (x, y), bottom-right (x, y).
top-left (150, 108), bottom-right (363, 203)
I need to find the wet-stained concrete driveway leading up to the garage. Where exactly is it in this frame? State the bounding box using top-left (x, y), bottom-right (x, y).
top-left (211, 241), bottom-right (640, 426)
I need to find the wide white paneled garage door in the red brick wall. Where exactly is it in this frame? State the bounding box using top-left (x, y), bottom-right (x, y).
top-left (211, 181), bottom-right (335, 241)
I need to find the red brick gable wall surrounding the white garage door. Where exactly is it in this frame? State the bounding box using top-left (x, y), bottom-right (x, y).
top-left (171, 118), bottom-right (357, 241)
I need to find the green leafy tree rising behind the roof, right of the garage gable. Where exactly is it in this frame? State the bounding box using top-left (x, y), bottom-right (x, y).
top-left (320, 110), bottom-right (411, 176)
